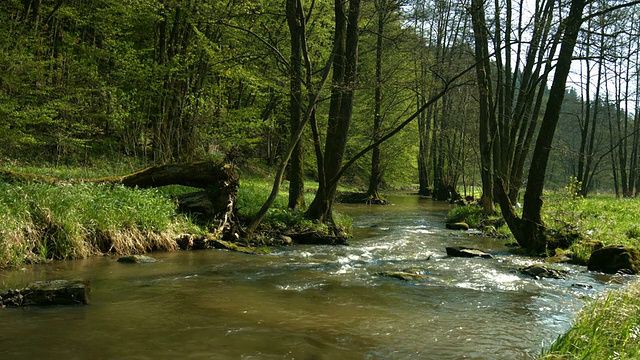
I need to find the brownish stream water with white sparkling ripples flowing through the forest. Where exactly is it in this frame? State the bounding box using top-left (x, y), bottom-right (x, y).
top-left (0, 195), bottom-right (632, 359)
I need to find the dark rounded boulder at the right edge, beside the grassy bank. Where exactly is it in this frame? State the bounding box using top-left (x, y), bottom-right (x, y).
top-left (587, 245), bottom-right (640, 274)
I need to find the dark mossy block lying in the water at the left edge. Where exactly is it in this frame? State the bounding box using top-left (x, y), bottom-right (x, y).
top-left (0, 280), bottom-right (91, 307)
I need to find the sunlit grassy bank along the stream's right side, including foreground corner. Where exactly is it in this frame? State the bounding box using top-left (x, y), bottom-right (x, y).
top-left (448, 192), bottom-right (640, 360)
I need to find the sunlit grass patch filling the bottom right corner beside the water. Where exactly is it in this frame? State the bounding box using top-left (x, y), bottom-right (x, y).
top-left (540, 281), bottom-right (640, 360)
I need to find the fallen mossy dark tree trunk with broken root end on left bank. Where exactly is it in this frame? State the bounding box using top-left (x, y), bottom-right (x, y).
top-left (0, 161), bottom-right (239, 239)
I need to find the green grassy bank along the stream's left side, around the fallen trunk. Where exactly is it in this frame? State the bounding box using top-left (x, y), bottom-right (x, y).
top-left (0, 164), bottom-right (350, 270)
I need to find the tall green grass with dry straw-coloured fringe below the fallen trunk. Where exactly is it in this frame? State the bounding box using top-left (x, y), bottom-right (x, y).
top-left (0, 182), bottom-right (195, 268)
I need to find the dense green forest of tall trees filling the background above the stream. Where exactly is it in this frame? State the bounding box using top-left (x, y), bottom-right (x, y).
top-left (0, 0), bottom-right (640, 243)
